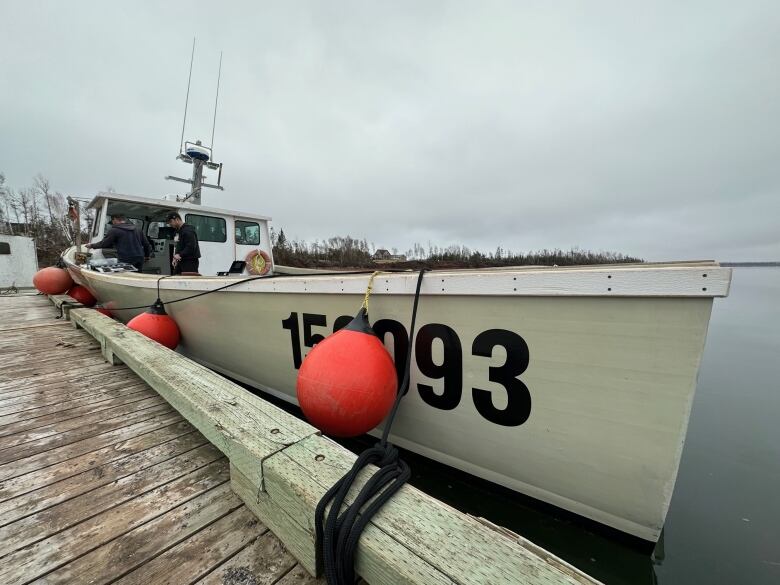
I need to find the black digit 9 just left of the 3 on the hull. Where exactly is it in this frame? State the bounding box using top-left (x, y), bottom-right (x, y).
top-left (414, 323), bottom-right (463, 410)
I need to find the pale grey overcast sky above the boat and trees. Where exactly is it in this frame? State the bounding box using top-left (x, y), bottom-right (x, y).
top-left (0, 0), bottom-right (780, 260)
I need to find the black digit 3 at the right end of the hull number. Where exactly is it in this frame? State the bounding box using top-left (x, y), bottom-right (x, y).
top-left (471, 329), bottom-right (531, 427)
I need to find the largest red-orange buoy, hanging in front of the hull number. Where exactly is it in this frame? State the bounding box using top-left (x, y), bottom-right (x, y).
top-left (296, 309), bottom-right (398, 437)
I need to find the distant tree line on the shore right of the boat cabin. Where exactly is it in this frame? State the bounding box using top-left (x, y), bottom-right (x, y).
top-left (271, 229), bottom-right (643, 269)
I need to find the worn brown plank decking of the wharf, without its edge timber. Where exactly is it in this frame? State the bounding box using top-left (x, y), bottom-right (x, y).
top-left (0, 294), bottom-right (322, 585)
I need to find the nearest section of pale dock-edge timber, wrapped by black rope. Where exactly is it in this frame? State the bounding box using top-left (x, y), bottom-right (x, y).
top-left (231, 436), bottom-right (595, 585)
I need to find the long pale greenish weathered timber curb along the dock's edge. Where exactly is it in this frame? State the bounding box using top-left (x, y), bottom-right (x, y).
top-left (50, 295), bottom-right (599, 585)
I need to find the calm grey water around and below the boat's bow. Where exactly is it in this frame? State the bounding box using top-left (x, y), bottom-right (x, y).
top-left (386, 268), bottom-right (780, 585)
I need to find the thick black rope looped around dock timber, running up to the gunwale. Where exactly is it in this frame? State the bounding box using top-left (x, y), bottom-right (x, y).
top-left (314, 269), bottom-right (427, 585)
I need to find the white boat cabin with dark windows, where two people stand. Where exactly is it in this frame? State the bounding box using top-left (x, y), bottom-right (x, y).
top-left (87, 193), bottom-right (273, 276)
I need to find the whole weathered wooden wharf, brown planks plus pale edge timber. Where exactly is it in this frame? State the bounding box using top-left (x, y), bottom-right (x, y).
top-left (0, 294), bottom-right (598, 585)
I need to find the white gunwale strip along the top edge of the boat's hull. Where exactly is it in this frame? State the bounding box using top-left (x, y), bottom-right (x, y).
top-left (71, 264), bottom-right (731, 298)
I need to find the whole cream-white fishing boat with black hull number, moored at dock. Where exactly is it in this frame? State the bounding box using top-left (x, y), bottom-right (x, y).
top-left (63, 139), bottom-right (731, 541)
